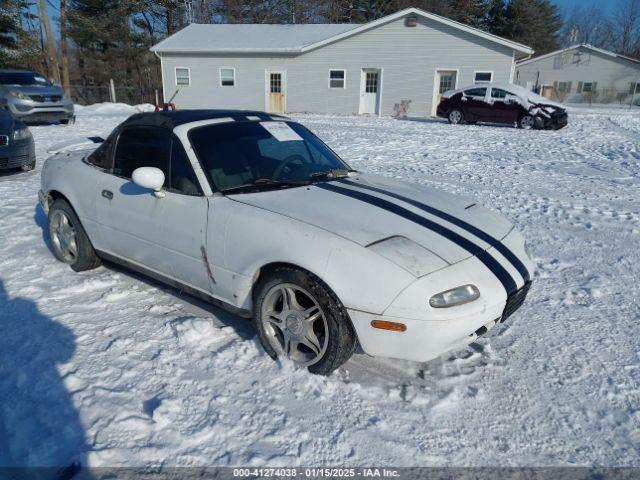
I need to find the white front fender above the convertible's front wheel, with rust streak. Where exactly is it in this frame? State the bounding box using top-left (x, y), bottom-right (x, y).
top-left (208, 197), bottom-right (415, 313)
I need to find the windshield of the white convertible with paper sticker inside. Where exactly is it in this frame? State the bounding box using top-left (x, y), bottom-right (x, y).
top-left (189, 121), bottom-right (350, 192)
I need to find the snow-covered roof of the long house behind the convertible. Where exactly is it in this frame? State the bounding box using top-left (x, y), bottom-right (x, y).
top-left (151, 8), bottom-right (533, 55)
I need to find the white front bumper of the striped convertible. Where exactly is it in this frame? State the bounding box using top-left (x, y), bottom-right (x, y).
top-left (348, 229), bottom-right (535, 362)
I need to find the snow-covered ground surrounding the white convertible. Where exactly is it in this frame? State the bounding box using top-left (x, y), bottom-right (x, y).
top-left (0, 106), bottom-right (640, 466)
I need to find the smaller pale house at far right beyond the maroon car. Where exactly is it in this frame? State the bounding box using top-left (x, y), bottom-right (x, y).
top-left (515, 44), bottom-right (640, 103)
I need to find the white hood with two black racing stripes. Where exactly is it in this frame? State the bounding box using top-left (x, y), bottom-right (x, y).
top-left (228, 174), bottom-right (512, 264)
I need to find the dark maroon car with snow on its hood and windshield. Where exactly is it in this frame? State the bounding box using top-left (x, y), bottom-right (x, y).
top-left (437, 83), bottom-right (568, 130)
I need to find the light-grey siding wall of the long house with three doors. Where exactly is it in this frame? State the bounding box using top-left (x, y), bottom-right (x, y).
top-left (162, 18), bottom-right (513, 115)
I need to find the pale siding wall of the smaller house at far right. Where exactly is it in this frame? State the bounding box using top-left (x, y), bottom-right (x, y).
top-left (515, 47), bottom-right (640, 102)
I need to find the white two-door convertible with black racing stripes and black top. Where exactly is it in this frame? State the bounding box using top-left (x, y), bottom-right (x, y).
top-left (39, 110), bottom-right (533, 374)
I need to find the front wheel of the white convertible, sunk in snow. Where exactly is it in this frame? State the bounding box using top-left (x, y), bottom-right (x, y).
top-left (253, 267), bottom-right (356, 375)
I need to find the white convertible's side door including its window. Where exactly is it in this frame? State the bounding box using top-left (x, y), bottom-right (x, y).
top-left (96, 126), bottom-right (212, 293)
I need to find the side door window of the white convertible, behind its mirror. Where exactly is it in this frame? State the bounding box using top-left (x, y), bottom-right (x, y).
top-left (112, 127), bottom-right (171, 182)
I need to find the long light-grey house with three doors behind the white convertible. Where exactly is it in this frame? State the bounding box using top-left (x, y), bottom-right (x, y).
top-left (151, 8), bottom-right (533, 115)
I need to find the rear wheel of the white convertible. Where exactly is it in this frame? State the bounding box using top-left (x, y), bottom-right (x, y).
top-left (49, 199), bottom-right (101, 272)
